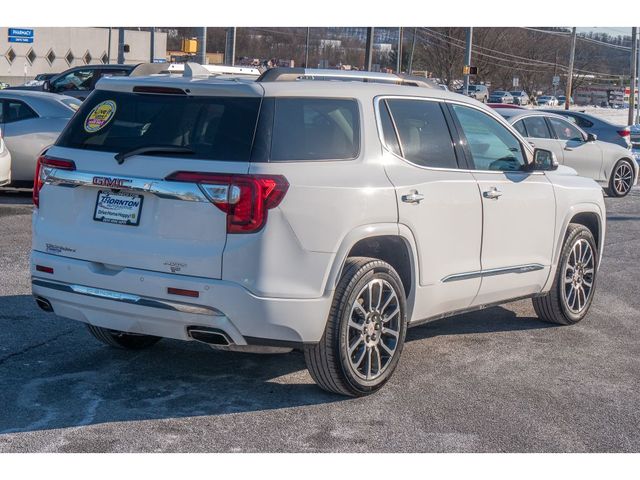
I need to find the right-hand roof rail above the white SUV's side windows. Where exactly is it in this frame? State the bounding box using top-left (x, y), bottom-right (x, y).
top-left (256, 67), bottom-right (436, 88)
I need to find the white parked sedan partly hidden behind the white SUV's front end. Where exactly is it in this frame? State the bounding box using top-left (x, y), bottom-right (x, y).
top-left (497, 108), bottom-right (639, 197)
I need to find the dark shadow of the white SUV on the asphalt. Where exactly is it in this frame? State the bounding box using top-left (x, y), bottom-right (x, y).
top-left (0, 295), bottom-right (548, 434)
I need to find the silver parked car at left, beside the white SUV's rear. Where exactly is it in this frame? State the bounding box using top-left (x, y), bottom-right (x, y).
top-left (0, 90), bottom-right (81, 187)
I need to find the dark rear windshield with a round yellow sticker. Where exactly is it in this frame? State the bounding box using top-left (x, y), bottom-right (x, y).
top-left (57, 90), bottom-right (261, 161)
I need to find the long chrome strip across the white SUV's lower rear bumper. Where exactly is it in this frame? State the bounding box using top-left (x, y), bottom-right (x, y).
top-left (31, 278), bottom-right (224, 316)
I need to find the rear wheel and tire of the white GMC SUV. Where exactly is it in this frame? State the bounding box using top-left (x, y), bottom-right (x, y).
top-left (304, 257), bottom-right (407, 397)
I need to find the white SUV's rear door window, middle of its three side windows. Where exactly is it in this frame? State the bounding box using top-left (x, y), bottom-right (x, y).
top-left (383, 99), bottom-right (458, 168)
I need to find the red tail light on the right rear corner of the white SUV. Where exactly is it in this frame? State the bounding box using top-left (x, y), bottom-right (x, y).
top-left (166, 172), bottom-right (289, 233)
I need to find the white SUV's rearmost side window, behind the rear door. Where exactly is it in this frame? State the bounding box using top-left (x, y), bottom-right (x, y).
top-left (270, 98), bottom-right (360, 161)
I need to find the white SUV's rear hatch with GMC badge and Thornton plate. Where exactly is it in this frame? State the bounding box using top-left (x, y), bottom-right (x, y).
top-left (33, 78), bottom-right (278, 278)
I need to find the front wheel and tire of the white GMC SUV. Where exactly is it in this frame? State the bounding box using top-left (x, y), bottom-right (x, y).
top-left (532, 223), bottom-right (598, 325)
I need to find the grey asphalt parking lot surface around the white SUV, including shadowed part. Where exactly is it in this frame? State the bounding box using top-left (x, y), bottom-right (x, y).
top-left (0, 187), bottom-right (640, 452)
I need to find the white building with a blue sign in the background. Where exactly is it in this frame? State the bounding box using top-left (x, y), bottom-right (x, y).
top-left (0, 27), bottom-right (167, 85)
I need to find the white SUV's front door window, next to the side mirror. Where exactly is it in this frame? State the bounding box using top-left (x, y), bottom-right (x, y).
top-left (452, 104), bottom-right (526, 171)
